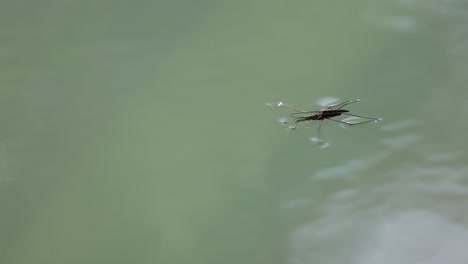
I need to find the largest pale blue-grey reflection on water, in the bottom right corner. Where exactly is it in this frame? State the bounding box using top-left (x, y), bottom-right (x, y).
top-left (353, 210), bottom-right (468, 264)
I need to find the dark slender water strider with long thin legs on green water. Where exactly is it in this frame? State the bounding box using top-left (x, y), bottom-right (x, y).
top-left (278, 100), bottom-right (381, 133)
